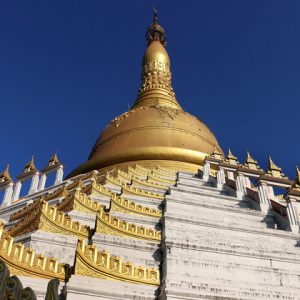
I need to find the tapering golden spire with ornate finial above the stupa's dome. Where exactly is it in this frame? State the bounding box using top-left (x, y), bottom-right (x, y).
top-left (132, 8), bottom-right (182, 110)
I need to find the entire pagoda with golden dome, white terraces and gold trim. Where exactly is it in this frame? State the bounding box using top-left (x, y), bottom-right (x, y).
top-left (0, 12), bottom-right (300, 300)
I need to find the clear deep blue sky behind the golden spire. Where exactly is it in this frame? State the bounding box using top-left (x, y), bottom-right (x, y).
top-left (0, 0), bottom-right (300, 177)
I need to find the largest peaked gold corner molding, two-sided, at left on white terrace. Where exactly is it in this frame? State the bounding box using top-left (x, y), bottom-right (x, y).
top-left (5, 201), bottom-right (89, 238)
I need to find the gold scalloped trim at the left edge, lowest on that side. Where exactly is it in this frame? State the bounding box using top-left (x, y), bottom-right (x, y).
top-left (0, 224), bottom-right (65, 280)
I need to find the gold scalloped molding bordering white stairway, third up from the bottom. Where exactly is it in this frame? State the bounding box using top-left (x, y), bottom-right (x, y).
top-left (111, 194), bottom-right (162, 218)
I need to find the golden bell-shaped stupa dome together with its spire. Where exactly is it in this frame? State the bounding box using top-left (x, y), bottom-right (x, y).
top-left (69, 14), bottom-right (223, 176)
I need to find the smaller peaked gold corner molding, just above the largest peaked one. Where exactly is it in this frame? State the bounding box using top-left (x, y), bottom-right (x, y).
top-left (57, 190), bottom-right (104, 214)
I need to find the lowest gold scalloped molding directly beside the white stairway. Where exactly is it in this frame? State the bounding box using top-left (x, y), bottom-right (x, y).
top-left (75, 240), bottom-right (160, 286)
